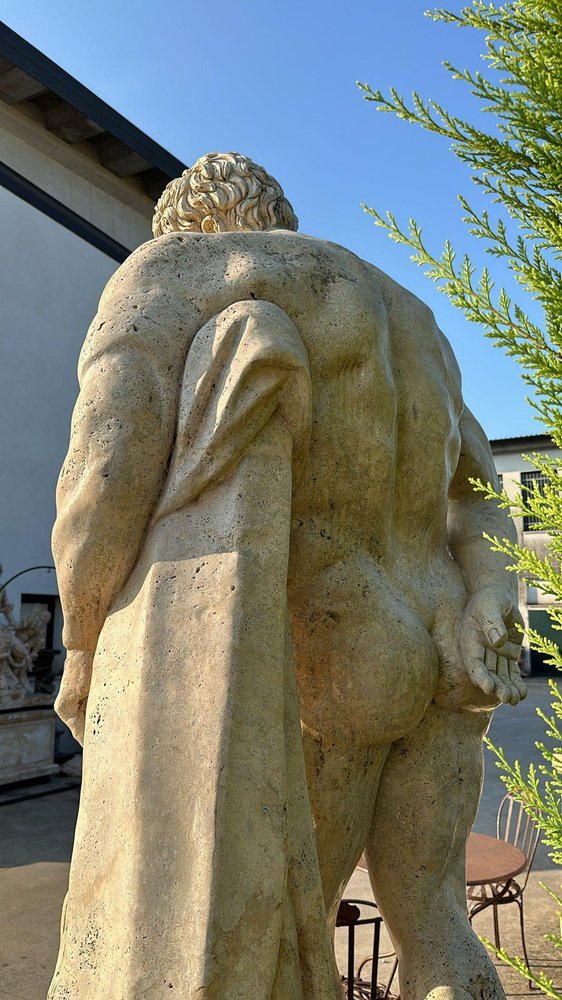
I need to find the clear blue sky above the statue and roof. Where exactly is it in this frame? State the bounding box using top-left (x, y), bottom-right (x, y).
top-left (0, 0), bottom-right (541, 437)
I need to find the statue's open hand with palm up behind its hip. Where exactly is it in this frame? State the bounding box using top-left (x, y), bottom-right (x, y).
top-left (460, 587), bottom-right (527, 705)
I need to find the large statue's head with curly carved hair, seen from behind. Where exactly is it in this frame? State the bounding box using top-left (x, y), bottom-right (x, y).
top-left (152, 153), bottom-right (298, 236)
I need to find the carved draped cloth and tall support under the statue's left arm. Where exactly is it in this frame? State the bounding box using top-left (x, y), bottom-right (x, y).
top-left (49, 301), bottom-right (337, 1000)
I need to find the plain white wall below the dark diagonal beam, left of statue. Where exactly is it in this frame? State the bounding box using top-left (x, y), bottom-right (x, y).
top-left (0, 188), bottom-right (122, 642)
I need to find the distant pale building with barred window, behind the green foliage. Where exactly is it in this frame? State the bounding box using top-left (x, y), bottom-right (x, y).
top-left (490, 434), bottom-right (562, 673)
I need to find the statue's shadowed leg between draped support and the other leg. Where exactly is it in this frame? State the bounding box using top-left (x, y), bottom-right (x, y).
top-left (304, 732), bottom-right (388, 972)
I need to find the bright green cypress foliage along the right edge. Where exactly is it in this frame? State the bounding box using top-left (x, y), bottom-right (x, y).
top-left (359, 0), bottom-right (562, 1000)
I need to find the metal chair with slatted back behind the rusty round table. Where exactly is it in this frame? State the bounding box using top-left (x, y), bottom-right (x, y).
top-left (467, 793), bottom-right (540, 989)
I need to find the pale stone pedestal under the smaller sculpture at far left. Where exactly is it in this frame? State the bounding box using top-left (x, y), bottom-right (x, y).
top-left (0, 695), bottom-right (59, 785)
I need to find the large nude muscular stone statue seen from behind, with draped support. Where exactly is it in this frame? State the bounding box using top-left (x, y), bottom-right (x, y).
top-left (49, 153), bottom-right (525, 1000)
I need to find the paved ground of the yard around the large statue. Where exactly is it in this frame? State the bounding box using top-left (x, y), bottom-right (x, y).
top-left (0, 679), bottom-right (562, 1000)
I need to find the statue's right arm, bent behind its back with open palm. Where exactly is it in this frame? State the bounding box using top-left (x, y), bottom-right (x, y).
top-left (448, 408), bottom-right (527, 704)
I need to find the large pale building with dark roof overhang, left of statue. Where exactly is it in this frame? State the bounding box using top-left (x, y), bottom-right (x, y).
top-left (0, 23), bottom-right (185, 664)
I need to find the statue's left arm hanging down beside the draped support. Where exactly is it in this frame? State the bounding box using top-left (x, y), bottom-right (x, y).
top-left (53, 245), bottom-right (190, 736)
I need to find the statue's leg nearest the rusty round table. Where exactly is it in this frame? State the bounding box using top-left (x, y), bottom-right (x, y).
top-left (366, 706), bottom-right (504, 1000)
